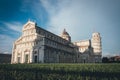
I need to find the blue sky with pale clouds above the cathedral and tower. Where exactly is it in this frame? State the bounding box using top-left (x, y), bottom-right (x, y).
top-left (0, 0), bottom-right (120, 56)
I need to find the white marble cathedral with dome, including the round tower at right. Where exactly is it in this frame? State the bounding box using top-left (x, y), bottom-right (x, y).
top-left (11, 21), bottom-right (102, 64)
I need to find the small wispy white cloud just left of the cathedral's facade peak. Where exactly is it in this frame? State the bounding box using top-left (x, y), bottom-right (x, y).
top-left (3, 22), bottom-right (23, 32)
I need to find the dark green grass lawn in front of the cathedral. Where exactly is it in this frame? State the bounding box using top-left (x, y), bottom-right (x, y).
top-left (0, 64), bottom-right (120, 80)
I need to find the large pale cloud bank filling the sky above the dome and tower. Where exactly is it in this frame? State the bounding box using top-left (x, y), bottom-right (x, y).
top-left (40, 0), bottom-right (119, 55)
